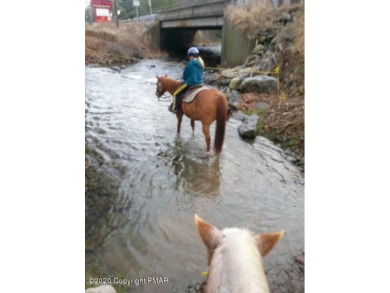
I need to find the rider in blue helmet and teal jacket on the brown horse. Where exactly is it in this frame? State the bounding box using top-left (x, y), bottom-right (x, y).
top-left (168, 47), bottom-right (204, 114)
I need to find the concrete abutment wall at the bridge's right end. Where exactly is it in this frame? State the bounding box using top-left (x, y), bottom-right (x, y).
top-left (221, 19), bottom-right (256, 66)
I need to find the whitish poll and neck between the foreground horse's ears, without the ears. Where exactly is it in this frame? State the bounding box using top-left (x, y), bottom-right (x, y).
top-left (207, 228), bottom-right (269, 293)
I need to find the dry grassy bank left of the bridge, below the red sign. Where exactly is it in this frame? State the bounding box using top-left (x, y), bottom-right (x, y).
top-left (85, 23), bottom-right (161, 65)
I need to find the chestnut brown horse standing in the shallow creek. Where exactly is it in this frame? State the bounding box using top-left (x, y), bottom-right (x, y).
top-left (156, 75), bottom-right (227, 154)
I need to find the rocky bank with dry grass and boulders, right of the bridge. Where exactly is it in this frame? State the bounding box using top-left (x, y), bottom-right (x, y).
top-left (216, 4), bottom-right (305, 170)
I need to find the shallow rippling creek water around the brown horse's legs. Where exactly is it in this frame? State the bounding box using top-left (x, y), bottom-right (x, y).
top-left (85, 60), bottom-right (304, 292)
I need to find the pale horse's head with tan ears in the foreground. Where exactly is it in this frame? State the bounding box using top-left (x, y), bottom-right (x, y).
top-left (195, 215), bottom-right (284, 292)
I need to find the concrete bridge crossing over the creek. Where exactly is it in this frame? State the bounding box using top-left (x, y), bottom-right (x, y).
top-left (146, 0), bottom-right (255, 66)
